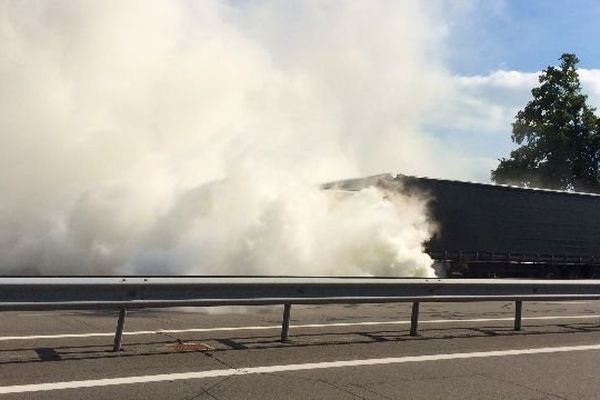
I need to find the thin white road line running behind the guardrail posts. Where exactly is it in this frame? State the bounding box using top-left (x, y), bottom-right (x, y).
top-left (0, 314), bottom-right (600, 342)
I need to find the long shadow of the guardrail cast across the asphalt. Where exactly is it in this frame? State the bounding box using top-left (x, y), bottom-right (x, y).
top-left (0, 323), bottom-right (600, 366)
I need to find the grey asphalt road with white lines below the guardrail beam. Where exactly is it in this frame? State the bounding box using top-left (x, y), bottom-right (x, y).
top-left (0, 302), bottom-right (600, 400)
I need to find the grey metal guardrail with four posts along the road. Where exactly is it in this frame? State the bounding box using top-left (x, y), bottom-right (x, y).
top-left (0, 276), bottom-right (600, 351)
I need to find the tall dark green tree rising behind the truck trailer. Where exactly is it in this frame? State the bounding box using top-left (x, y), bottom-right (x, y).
top-left (492, 54), bottom-right (600, 192)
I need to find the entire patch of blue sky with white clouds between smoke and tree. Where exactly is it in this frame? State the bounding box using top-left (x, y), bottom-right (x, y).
top-left (425, 0), bottom-right (600, 181)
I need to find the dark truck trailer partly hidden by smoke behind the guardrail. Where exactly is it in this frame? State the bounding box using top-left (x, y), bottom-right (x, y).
top-left (326, 174), bottom-right (600, 279)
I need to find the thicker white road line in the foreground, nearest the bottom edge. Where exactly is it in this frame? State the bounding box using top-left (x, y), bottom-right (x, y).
top-left (0, 344), bottom-right (600, 394)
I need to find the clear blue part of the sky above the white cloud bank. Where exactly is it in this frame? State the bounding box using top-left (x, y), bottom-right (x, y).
top-left (449, 0), bottom-right (600, 75)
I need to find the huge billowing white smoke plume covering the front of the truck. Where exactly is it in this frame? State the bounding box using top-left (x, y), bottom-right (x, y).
top-left (0, 0), bottom-right (450, 276)
